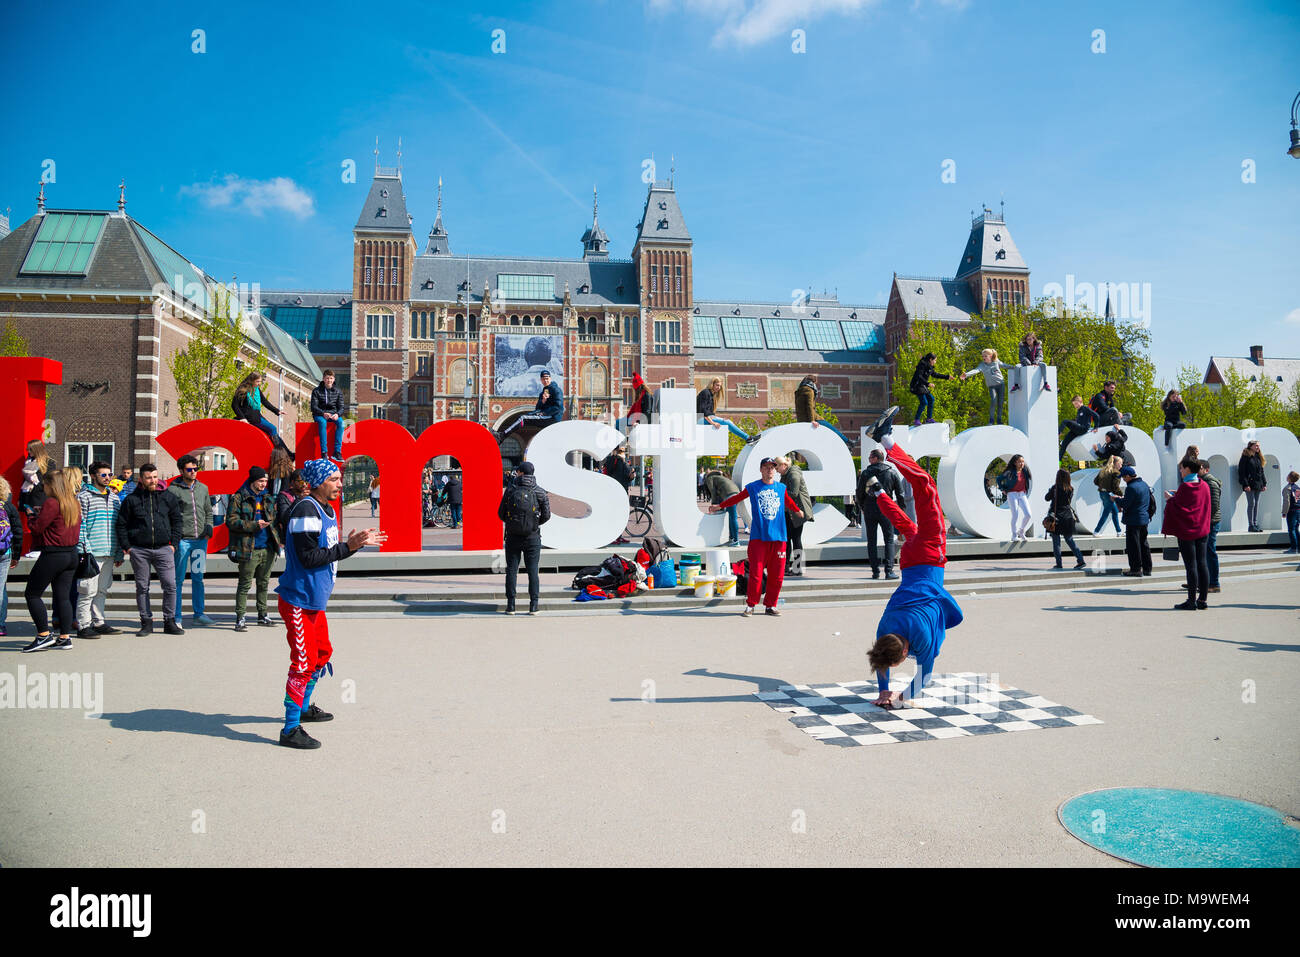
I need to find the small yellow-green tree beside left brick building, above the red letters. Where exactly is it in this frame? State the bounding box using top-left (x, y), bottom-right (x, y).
top-left (166, 285), bottom-right (253, 423)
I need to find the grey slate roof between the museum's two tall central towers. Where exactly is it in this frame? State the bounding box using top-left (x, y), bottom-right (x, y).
top-left (411, 256), bottom-right (641, 308)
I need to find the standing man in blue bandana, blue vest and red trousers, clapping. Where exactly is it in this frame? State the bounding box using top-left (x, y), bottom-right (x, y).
top-left (276, 459), bottom-right (387, 749)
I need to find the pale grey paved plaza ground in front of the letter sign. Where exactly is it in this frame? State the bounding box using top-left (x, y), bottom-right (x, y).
top-left (0, 567), bottom-right (1300, 867)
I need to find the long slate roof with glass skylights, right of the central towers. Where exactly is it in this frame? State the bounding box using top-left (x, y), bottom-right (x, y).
top-left (692, 296), bottom-right (885, 365)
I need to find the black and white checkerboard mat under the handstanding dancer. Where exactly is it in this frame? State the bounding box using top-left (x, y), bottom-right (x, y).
top-left (754, 672), bottom-right (1101, 748)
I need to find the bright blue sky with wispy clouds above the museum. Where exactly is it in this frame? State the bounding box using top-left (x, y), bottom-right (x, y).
top-left (0, 0), bottom-right (1300, 378)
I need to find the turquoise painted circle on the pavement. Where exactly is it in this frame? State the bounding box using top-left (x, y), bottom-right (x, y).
top-left (1057, 788), bottom-right (1300, 867)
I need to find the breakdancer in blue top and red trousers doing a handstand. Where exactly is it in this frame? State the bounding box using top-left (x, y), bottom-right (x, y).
top-left (865, 406), bottom-right (962, 707)
